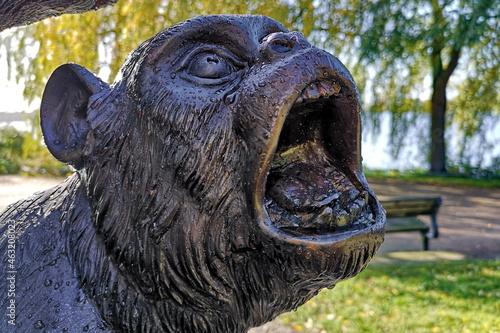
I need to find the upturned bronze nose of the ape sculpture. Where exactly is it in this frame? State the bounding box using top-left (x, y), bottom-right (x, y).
top-left (260, 31), bottom-right (311, 61)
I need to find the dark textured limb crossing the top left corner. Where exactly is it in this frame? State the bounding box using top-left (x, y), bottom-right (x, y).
top-left (0, 0), bottom-right (117, 31)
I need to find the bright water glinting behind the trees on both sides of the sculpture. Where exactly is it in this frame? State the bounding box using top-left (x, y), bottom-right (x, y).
top-left (0, 112), bottom-right (500, 170)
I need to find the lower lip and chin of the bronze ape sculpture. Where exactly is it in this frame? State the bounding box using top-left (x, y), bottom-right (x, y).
top-left (260, 196), bottom-right (385, 282)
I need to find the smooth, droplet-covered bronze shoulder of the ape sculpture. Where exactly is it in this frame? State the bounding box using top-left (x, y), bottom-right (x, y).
top-left (0, 179), bottom-right (112, 332)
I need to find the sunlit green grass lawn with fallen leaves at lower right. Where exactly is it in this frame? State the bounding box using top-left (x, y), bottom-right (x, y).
top-left (279, 261), bottom-right (500, 333)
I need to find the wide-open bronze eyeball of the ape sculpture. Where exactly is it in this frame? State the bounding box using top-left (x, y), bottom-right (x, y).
top-left (187, 53), bottom-right (234, 79)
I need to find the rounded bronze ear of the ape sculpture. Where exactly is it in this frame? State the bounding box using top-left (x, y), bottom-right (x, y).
top-left (40, 64), bottom-right (108, 169)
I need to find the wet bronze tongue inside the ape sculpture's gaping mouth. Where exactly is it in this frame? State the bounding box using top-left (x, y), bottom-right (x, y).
top-left (266, 162), bottom-right (368, 231)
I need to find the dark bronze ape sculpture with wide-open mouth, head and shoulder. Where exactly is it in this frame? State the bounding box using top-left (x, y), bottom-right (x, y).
top-left (0, 16), bottom-right (385, 332)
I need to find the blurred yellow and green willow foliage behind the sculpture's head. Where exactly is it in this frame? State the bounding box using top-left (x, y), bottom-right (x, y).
top-left (0, 0), bottom-right (500, 176)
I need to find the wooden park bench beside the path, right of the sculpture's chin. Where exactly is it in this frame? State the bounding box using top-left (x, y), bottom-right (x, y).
top-left (380, 197), bottom-right (441, 251)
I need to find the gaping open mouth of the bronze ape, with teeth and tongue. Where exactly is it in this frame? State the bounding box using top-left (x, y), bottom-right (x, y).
top-left (263, 75), bottom-right (383, 242)
